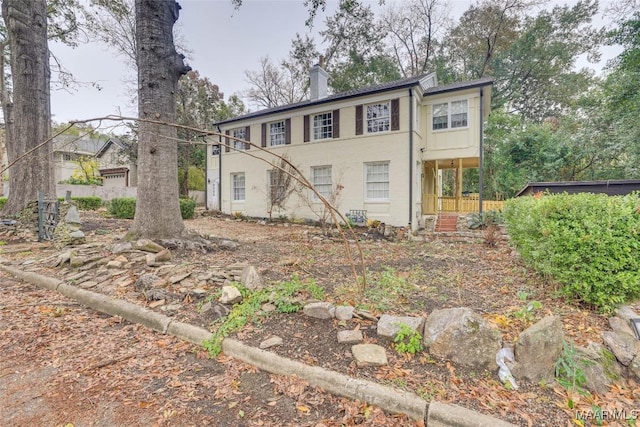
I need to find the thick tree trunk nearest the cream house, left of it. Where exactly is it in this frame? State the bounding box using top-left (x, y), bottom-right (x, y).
top-left (131, 0), bottom-right (189, 238)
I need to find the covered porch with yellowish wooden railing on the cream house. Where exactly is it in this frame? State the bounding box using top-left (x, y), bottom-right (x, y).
top-left (422, 157), bottom-right (504, 215)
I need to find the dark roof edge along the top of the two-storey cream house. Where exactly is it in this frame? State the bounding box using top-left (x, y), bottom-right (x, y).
top-left (214, 73), bottom-right (493, 125)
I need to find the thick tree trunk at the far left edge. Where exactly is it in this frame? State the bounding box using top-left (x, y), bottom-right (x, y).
top-left (2, 0), bottom-right (55, 216)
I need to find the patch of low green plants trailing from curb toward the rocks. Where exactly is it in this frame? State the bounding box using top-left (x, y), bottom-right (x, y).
top-left (203, 276), bottom-right (324, 357)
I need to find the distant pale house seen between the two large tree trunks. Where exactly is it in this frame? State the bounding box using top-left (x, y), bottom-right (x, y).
top-left (53, 135), bottom-right (137, 187)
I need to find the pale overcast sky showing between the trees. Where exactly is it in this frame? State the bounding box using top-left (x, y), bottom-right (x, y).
top-left (49, 0), bottom-right (617, 130)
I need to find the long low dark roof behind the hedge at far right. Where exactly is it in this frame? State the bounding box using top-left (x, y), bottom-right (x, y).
top-left (516, 179), bottom-right (640, 197)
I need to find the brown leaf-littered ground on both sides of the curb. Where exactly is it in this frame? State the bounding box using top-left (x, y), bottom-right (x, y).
top-left (0, 212), bottom-right (640, 426)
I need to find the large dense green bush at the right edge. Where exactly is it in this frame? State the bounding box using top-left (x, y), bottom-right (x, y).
top-left (505, 193), bottom-right (640, 311)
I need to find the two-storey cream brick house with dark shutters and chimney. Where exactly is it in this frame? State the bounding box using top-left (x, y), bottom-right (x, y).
top-left (207, 65), bottom-right (492, 229)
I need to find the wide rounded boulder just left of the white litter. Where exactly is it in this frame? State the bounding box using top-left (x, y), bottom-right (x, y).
top-left (423, 308), bottom-right (502, 369)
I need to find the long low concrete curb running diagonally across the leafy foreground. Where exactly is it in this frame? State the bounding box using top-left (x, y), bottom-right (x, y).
top-left (0, 263), bottom-right (515, 427)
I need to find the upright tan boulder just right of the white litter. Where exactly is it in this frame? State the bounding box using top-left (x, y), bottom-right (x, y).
top-left (511, 316), bottom-right (564, 382)
